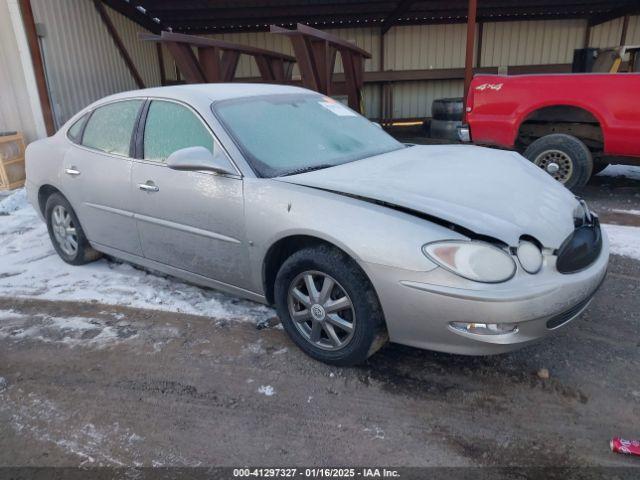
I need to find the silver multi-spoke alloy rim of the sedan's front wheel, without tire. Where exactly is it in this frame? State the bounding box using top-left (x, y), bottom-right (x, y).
top-left (287, 270), bottom-right (356, 350)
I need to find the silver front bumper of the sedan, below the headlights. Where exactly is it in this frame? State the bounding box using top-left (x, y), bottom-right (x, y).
top-left (365, 234), bottom-right (609, 355)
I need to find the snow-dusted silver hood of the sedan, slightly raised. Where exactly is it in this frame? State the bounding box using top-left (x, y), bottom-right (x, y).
top-left (277, 145), bottom-right (579, 249)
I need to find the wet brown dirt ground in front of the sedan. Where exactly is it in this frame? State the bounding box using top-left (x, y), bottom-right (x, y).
top-left (0, 160), bottom-right (640, 468)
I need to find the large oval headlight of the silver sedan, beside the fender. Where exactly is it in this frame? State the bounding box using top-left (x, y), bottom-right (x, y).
top-left (422, 240), bottom-right (516, 283)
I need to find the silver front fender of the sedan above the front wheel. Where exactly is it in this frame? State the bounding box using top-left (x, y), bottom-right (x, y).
top-left (245, 179), bottom-right (466, 292)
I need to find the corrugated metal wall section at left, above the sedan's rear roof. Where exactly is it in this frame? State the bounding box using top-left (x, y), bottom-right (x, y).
top-left (31, 0), bottom-right (160, 126)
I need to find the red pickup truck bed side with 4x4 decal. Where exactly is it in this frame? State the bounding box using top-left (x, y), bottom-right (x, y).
top-left (466, 73), bottom-right (640, 158)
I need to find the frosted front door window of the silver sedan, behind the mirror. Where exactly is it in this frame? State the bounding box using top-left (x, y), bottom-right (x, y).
top-left (144, 100), bottom-right (213, 162)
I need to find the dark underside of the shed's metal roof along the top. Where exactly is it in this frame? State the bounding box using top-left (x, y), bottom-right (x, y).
top-left (103, 0), bottom-right (640, 34)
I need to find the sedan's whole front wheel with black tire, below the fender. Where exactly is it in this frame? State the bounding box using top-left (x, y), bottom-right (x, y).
top-left (275, 246), bottom-right (388, 366)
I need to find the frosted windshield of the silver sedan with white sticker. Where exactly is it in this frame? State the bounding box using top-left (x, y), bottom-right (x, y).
top-left (212, 94), bottom-right (404, 177)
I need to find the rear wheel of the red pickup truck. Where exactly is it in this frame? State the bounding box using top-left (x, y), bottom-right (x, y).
top-left (524, 133), bottom-right (593, 190)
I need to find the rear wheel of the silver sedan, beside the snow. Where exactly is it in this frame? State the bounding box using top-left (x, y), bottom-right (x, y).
top-left (44, 193), bottom-right (102, 265)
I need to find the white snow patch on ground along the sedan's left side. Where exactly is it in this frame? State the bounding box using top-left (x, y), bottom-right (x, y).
top-left (0, 189), bottom-right (275, 323)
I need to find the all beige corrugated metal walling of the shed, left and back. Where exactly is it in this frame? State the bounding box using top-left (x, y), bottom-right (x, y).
top-left (10, 4), bottom-right (640, 125)
